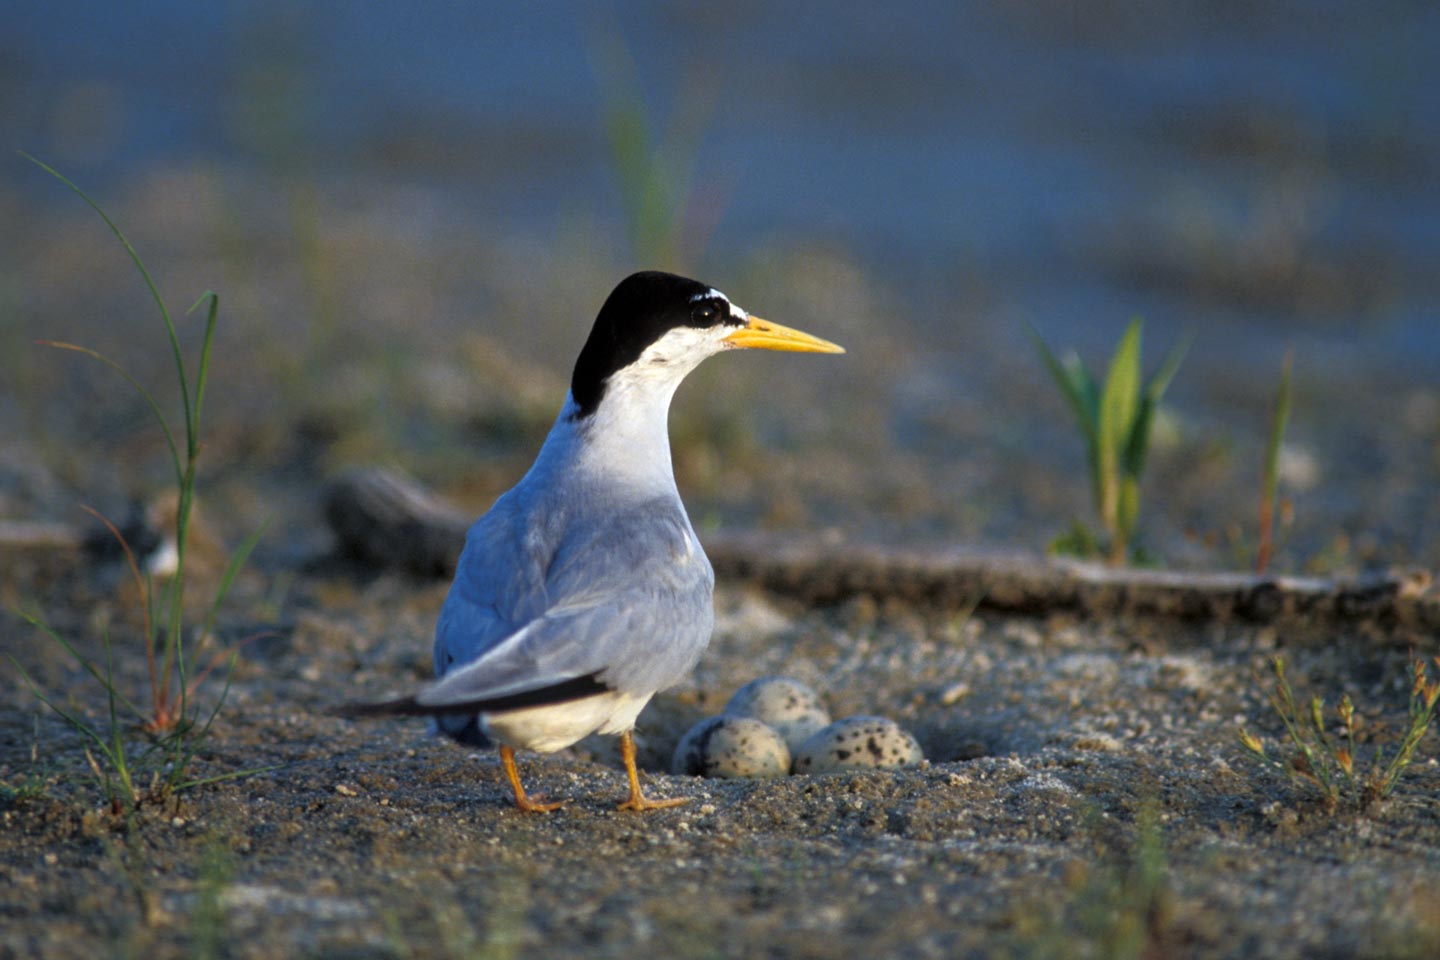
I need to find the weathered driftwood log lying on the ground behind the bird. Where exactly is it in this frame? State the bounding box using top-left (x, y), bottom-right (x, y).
top-left (327, 469), bottom-right (1440, 630)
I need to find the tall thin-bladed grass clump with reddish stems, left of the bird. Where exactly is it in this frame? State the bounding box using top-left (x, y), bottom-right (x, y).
top-left (10, 154), bottom-right (264, 812)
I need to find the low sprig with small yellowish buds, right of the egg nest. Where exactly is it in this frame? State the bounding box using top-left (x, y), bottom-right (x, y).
top-left (1240, 656), bottom-right (1440, 813)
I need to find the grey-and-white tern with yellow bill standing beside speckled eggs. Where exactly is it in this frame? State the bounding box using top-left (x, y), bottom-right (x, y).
top-left (347, 271), bottom-right (845, 812)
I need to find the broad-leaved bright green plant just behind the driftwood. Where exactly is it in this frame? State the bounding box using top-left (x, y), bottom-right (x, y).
top-left (1030, 318), bottom-right (1189, 566)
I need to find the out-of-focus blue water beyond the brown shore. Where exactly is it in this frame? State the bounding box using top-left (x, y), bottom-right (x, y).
top-left (0, 0), bottom-right (1440, 368)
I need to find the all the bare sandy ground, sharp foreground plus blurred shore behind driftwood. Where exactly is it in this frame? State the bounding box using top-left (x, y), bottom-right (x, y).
top-left (0, 170), bottom-right (1440, 960)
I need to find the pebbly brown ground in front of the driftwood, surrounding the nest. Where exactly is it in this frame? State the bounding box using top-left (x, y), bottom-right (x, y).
top-left (0, 544), bottom-right (1440, 957)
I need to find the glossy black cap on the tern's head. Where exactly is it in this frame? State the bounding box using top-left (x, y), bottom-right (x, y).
top-left (570, 271), bottom-right (742, 417)
